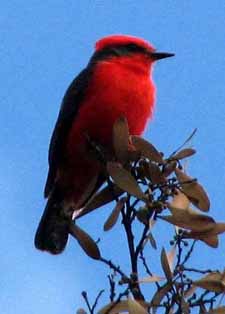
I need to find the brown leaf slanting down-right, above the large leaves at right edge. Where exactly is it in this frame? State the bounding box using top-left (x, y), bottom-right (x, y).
top-left (175, 168), bottom-right (210, 211)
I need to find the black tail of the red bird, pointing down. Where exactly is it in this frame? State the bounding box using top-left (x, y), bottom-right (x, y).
top-left (34, 192), bottom-right (70, 254)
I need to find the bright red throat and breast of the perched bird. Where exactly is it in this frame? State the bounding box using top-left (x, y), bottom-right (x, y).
top-left (68, 56), bottom-right (155, 152)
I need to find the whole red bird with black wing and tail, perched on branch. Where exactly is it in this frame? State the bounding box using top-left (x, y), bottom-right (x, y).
top-left (35, 35), bottom-right (173, 254)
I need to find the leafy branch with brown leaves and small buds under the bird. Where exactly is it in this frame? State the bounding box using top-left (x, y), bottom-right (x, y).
top-left (71, 117), bottom-right (225, 314)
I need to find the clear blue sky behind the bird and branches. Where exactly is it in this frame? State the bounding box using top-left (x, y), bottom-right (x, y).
top-left (0, 0), bottom-right (225, 314)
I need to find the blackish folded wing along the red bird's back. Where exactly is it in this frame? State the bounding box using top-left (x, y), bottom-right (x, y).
top-left (44, 66), bottom-right (92, 197)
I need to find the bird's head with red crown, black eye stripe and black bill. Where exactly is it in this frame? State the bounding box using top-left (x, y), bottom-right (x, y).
top-left (91, 35), bottom-right (174, 71)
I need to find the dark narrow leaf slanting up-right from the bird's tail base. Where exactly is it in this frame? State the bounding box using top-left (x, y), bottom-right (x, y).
top-left (78, 184), bottom-right (124, 217)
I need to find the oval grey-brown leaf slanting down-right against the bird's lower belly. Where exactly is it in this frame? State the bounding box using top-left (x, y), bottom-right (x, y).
top-left (107, 162), bottom-right (146, 200)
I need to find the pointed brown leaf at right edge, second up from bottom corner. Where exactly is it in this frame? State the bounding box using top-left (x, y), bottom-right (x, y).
top-left (193, 272), bottom-right (225, 293)
